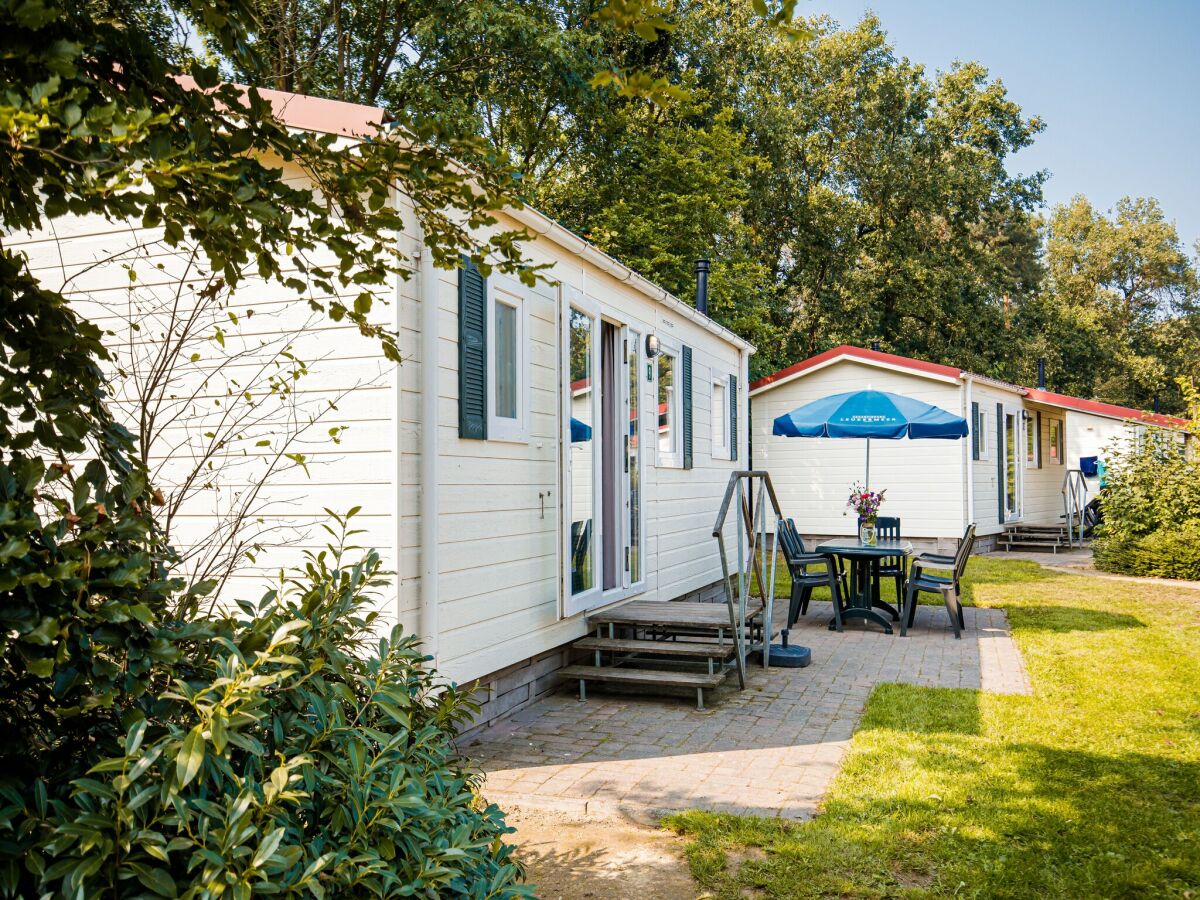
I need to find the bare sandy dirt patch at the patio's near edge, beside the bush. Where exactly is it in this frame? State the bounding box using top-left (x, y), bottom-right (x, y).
top-left (506, 806), bottom-right (706, 900)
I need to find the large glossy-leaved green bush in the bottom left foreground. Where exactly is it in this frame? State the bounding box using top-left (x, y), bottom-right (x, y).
top-left (0, 518), bottom-right (527, 898)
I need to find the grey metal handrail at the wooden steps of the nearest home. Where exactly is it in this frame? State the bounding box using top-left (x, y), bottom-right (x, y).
top-left (713, 470), bottom-right (784, 688)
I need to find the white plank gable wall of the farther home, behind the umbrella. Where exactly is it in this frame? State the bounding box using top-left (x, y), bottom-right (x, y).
top-left (750, 360), bottom-right (962, 547)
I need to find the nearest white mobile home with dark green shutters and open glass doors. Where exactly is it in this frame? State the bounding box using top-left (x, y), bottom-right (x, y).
top-left (10, 91), bottom-right (754, 734)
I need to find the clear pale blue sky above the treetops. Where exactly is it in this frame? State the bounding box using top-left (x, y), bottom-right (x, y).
top-left (816, 0), bottom-right (1200, 252)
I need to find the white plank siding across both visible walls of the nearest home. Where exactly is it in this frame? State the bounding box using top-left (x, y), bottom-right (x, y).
top-left (8, 173), bottom-right (745, 683)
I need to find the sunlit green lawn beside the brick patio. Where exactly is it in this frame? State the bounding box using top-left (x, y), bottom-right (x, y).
top-left (667, 558), bottom-right (1200, 898)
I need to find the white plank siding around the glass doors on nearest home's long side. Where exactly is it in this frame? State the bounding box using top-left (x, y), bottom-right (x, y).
top-left (412, 210), bottom-right (739, 691)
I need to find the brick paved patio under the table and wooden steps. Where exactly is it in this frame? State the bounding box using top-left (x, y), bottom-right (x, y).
top-left (463, 602), bottom-right (1030, 818)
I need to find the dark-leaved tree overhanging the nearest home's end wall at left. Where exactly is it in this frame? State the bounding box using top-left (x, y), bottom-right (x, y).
top-left (0, 0), bottom-right (533, 895)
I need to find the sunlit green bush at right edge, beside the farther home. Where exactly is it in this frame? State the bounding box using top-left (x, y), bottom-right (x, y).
top-left (1096, 430), bottom-right (1200, 578)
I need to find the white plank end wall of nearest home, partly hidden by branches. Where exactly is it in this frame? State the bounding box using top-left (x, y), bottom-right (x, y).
top-left (6, 168), bottom-right (413, 628)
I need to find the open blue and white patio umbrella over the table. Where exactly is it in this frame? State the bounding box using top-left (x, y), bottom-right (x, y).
top-left (772, 390), bottom-right (967, 487)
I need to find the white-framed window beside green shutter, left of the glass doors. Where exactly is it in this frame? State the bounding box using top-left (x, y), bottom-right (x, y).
top-left (487, 276), bottom-right (529, 440)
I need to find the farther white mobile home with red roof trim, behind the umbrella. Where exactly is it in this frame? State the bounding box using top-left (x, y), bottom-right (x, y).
top-left (750, 346), bottom-right (1181, 550)
